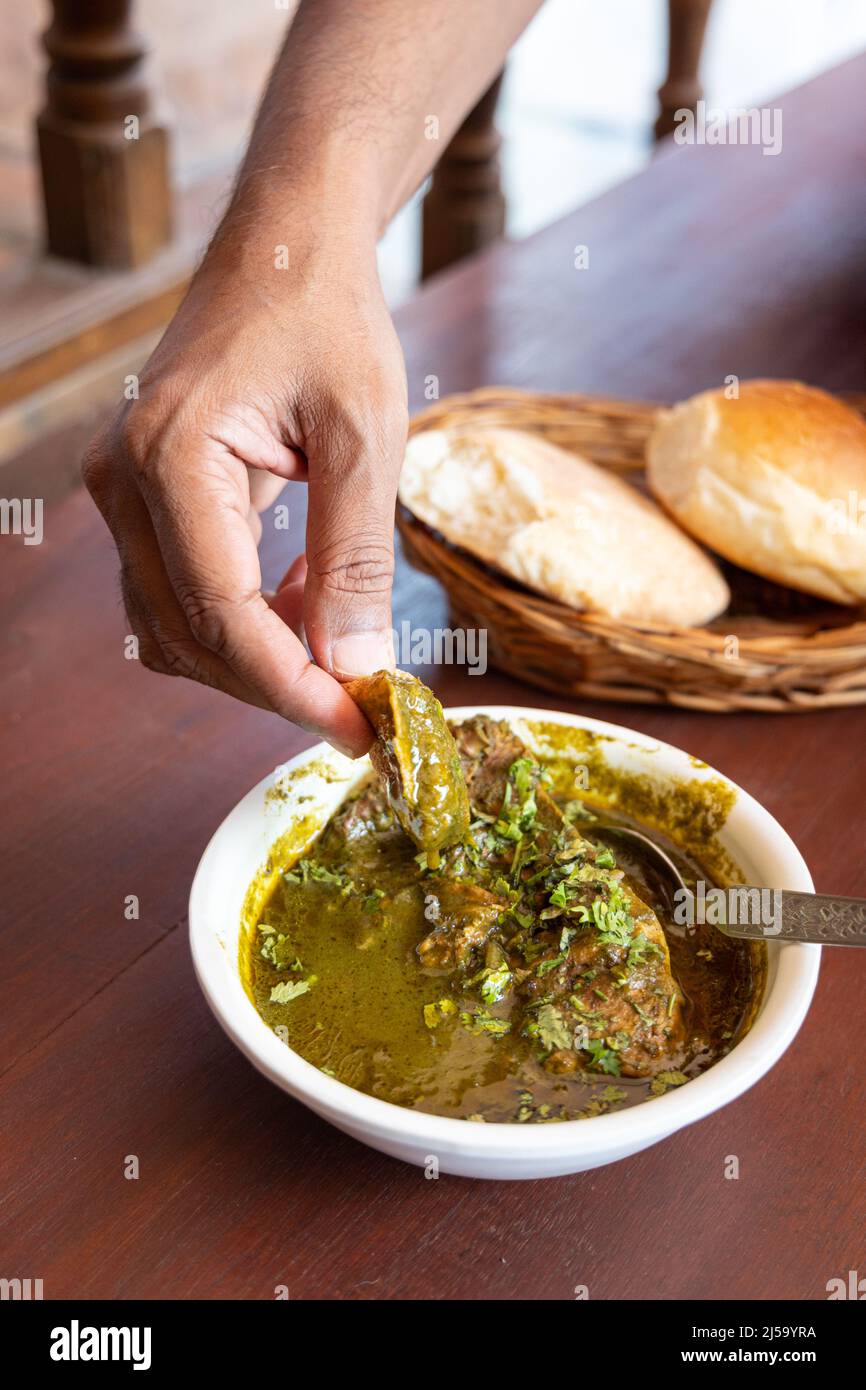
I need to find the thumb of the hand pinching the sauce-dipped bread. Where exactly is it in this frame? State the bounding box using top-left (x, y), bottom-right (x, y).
top-left (304, 414), bottom-right (405, 680)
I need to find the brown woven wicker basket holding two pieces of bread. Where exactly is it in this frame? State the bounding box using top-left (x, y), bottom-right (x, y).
top-left (398, 389), bottom-right (866, 712)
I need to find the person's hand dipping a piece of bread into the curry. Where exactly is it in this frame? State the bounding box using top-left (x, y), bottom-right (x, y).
top-left (83, 233), bottom-right (406, 755)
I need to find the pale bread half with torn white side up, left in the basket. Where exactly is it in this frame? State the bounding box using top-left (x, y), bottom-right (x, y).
top-left (399, 427), bottom-right (730, 627)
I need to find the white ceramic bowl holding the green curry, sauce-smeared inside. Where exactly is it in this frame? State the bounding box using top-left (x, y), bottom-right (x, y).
top-left (189, 706), bottom-right (820, 1179)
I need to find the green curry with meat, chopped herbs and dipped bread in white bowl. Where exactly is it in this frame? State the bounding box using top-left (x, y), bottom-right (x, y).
top-left (242, 673), bottom-right (765, 1123)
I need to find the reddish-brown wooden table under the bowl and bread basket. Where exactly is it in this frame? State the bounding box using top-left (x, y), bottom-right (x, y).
top-left (0, 58), bottom-right (866, 1300)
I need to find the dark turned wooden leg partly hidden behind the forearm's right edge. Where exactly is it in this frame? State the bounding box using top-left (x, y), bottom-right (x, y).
top-left (421, 72), bottom-right (505, 278)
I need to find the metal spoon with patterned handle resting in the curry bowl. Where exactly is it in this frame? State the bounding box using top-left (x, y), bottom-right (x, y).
top-left (592, 826), bottom-right (866, 947)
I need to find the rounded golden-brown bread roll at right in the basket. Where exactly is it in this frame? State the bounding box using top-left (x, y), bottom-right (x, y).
top-left (646, 381), bottom-right (866, 603)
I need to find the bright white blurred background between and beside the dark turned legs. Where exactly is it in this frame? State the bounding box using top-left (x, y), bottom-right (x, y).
top-left (382, 0), bottom-right (866, 300)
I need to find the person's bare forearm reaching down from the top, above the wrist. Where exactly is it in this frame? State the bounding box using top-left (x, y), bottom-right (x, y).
top-left (209, 0), bottom-right (541, 264)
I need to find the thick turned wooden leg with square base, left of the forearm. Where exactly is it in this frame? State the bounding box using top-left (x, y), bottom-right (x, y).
top-left (36, 0), bottom-right (171, 270)
